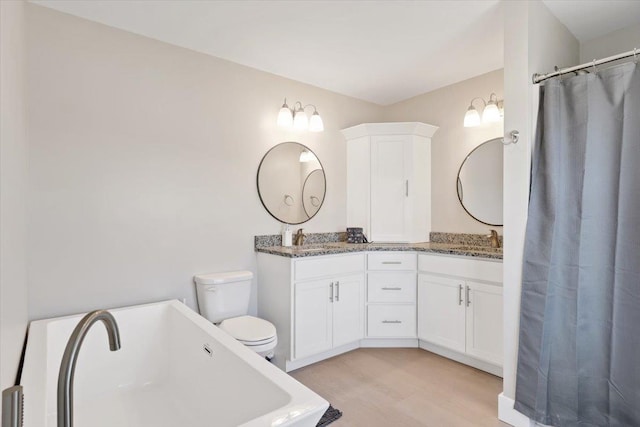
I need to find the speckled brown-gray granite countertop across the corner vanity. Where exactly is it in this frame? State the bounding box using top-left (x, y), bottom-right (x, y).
top-left (256, 242), bottom-right (502, 260)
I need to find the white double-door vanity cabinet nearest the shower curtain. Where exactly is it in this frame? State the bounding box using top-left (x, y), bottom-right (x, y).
top-left (418, 254), bottom-right (503, 375)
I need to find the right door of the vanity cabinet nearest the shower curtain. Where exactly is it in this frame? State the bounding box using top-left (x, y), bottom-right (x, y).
top-left (467, 281), bottom-right (502, 366)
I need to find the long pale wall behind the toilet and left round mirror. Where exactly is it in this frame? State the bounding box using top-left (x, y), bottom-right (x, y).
top-left (28, 5), bottom-right (382, 319)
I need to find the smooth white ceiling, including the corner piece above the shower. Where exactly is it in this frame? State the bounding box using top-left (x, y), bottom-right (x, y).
top-left (32, 0), bottom-right (640, 105)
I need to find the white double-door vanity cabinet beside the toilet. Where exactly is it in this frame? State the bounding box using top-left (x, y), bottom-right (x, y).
top-left (258, 253), bottom-right (365, 371)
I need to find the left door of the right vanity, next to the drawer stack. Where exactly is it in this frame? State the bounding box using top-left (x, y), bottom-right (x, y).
top-left (418, 274), bottom-right (465, 352)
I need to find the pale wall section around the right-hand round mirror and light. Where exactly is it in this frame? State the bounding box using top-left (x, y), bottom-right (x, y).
top-left (385, 70), bottom-right (509, 234)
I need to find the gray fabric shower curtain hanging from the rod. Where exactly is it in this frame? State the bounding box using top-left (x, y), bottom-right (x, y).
top-left (515, 63), bottom-right (640, 427)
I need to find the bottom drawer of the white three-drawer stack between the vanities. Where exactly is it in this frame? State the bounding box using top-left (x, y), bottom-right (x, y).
top-left (367, 304), bottom-right (416, 338)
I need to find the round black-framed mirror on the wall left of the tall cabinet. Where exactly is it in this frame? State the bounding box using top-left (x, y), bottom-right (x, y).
top-left (257, 142), bottom-right (326, 224)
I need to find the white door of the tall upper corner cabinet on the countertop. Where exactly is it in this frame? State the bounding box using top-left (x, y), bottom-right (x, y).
top-left (370, 136), bottom-right (410, 242)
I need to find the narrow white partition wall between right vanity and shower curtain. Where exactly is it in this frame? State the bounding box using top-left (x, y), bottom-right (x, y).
top-left (499, 0), bottom-right (579, 426)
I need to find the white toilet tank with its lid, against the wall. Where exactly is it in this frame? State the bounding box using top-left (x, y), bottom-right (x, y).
top-left (194, 271), bottom-right (253, 323)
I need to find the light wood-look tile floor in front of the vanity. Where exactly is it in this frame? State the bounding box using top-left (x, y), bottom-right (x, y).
top-left (290, 348), bottom-right (508, 427)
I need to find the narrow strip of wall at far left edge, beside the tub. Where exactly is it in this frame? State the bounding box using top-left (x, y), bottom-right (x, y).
top-left (0, 1), bottom-right (27, 390)
